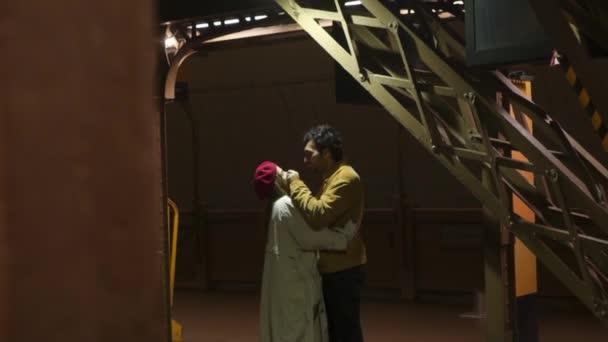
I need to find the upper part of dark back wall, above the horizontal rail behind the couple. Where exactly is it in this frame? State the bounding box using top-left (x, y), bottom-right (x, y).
top-left (168, 39), bottom-right (478, 210)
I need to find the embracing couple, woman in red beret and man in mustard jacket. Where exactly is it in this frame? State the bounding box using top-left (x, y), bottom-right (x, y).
top-left (253, 125), bottom-right (366, 342)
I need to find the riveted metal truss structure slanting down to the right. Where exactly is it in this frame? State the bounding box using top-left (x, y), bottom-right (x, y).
top-left (160, 0), bottom-right (608, 328)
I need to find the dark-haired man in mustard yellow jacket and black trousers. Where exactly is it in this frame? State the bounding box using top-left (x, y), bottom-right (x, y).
top-left (288, 125), bottom-right (367, 342)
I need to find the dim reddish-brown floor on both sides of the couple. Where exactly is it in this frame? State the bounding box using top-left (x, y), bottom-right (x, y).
top-left (174, 291), bottom-right (608, 342)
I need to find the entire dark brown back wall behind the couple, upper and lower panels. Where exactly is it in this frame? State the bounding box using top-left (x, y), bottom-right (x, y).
top-left (168, 32), bottom-right (592, 300)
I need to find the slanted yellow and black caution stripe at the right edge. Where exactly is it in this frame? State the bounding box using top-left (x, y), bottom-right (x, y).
top-left (551, 52), bottom-right (608, 151)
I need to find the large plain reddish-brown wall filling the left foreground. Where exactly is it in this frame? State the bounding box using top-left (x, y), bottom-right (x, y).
top-left (0, 0), bottom-right (169, 342)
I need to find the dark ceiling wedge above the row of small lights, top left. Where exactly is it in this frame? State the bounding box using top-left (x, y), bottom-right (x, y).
top-left (158, 0), bottom-right (278, 23)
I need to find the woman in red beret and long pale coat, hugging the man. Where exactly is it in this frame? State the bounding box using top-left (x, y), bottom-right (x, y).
top-left (253, 162), bottom-right (356, 342)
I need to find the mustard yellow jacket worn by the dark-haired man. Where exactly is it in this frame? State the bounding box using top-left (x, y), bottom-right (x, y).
top-left (289, 163), bottom-right (367, 273)
